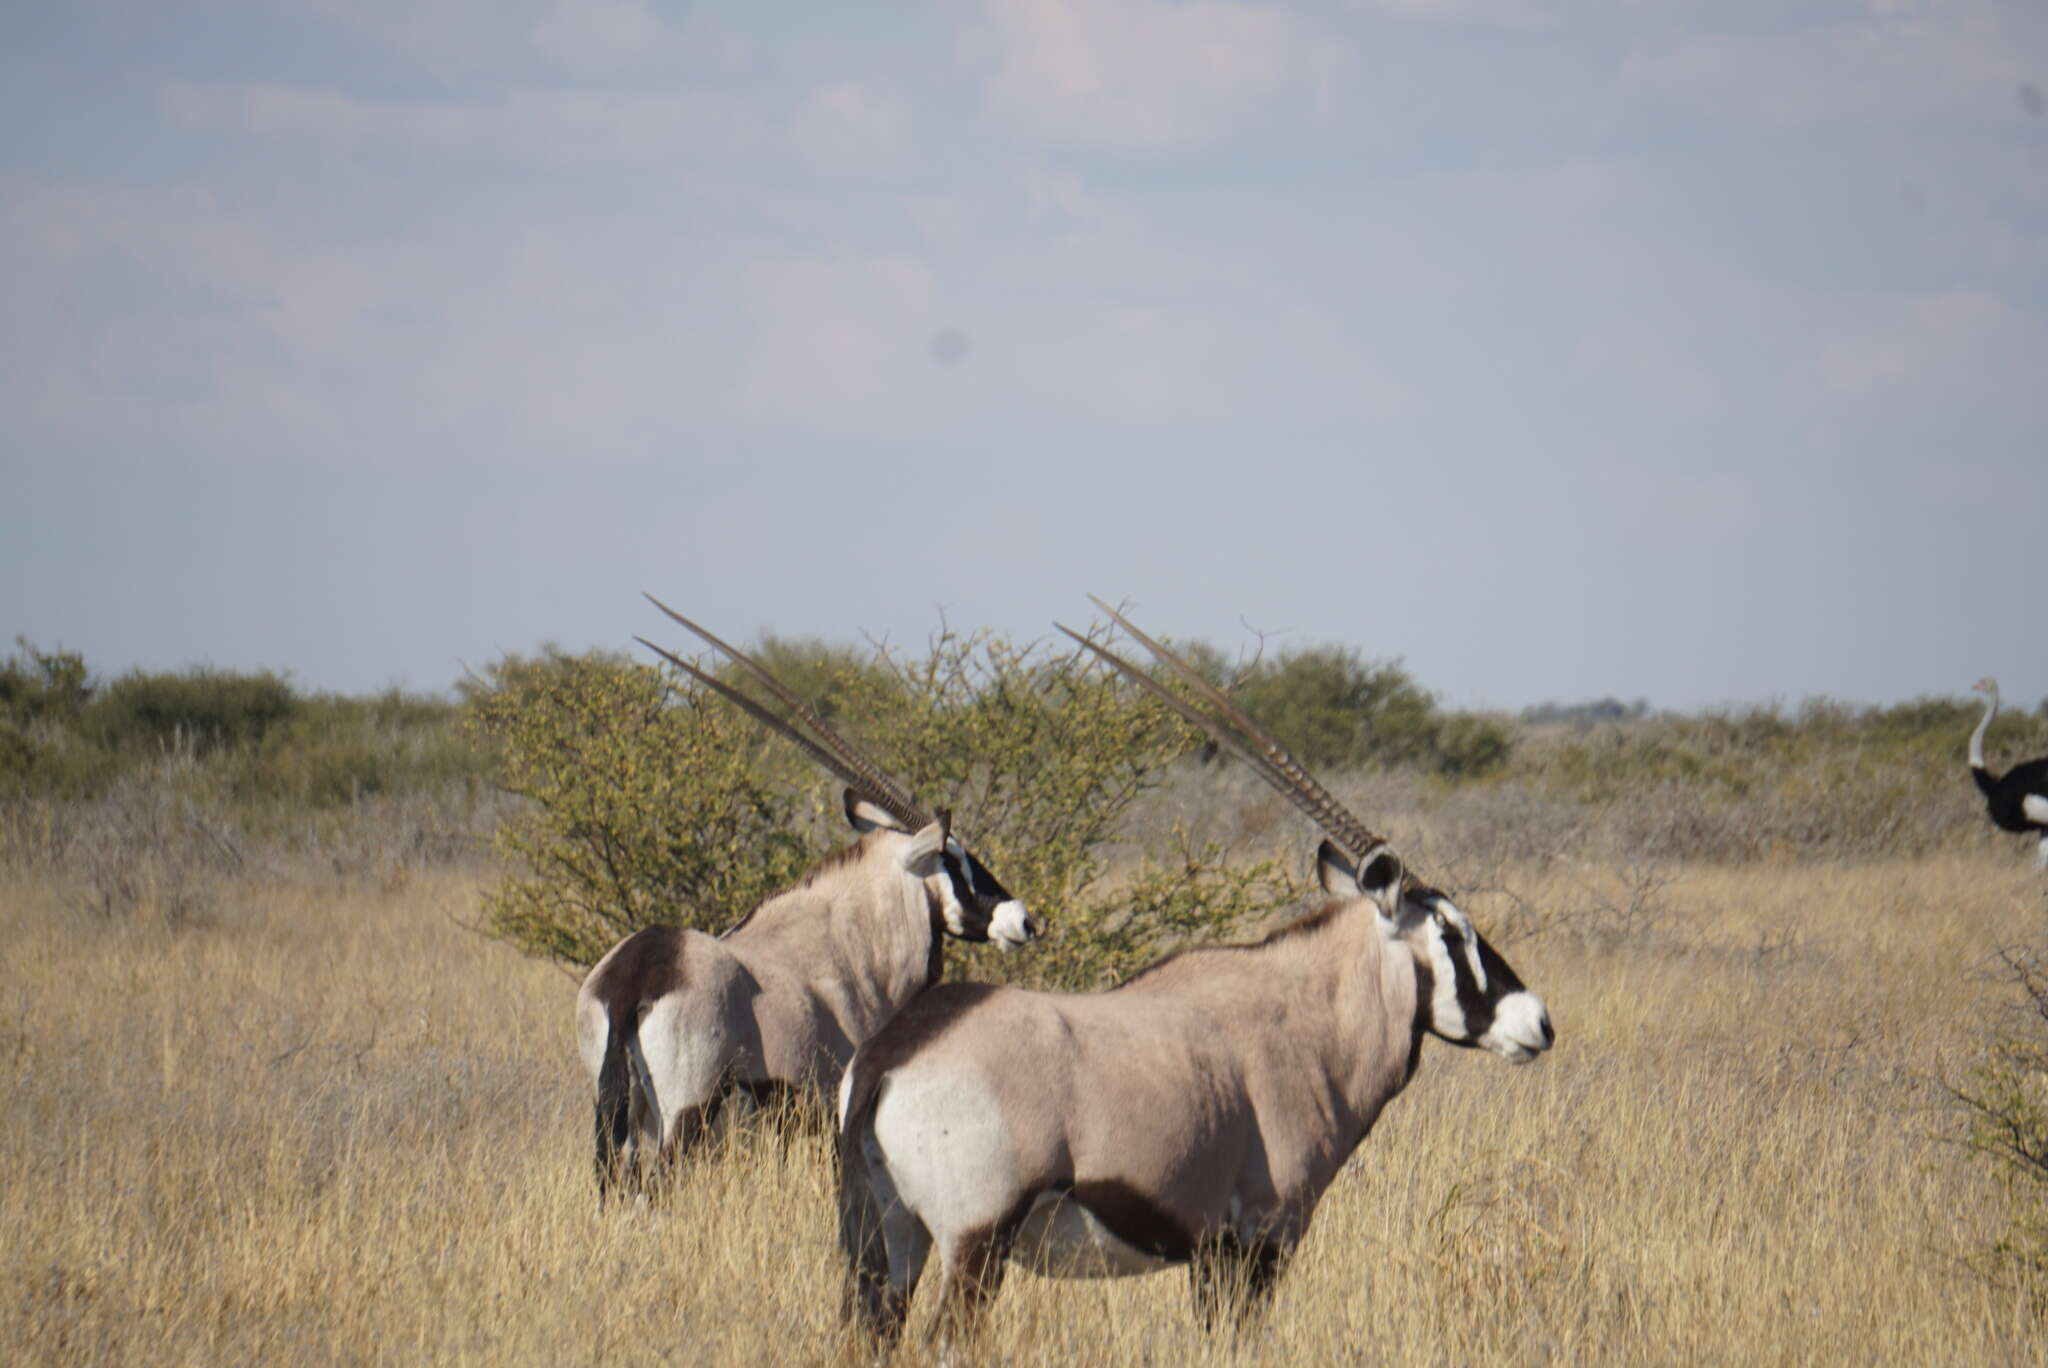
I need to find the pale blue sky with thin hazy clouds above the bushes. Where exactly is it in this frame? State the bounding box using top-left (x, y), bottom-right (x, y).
top-left (0, 0), bottom-right (2048, 707)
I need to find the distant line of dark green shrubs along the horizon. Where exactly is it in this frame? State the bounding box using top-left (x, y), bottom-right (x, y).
top-left (0, 639), bottom-right (2048, 823)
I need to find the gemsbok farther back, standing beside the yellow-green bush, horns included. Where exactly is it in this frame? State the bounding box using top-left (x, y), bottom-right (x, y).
top-left (575, 596), bottom-right (1038, 1200)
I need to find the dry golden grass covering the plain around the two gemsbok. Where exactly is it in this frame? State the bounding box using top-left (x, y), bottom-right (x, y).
top-left (0, 854), bottom-right (2048, 1364)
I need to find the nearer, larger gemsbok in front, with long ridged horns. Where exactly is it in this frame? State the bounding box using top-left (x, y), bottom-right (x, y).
top-left (840, 600), bottom-right (1554, 1341)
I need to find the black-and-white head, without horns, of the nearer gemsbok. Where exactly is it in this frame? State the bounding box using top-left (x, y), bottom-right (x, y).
top-left (1317, 840), bottom-right (1556, 1065)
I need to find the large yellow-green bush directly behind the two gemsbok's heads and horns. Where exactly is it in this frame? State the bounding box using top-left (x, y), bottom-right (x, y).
top-left (469, 631), bottom-right (1296, 985)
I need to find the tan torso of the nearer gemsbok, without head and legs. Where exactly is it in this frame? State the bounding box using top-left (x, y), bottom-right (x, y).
top-left (870, 907), bottom-right (1415, 1272)
